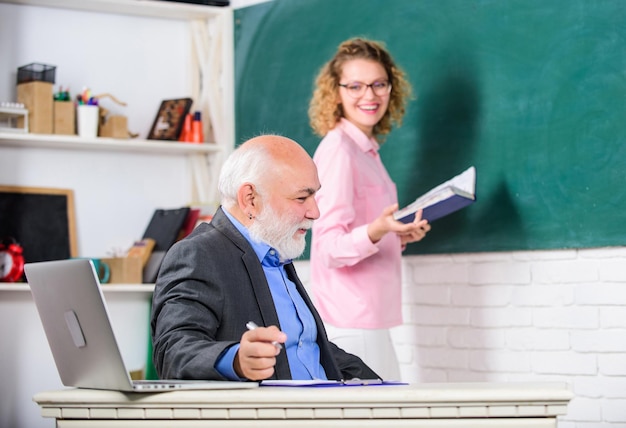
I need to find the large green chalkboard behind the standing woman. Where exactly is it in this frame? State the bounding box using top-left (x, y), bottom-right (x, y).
top-left (235, 0), bottom-right (626, 254)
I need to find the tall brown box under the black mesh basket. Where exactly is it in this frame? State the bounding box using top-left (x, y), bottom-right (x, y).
top-left (17, 82), bottom-right (54, 134)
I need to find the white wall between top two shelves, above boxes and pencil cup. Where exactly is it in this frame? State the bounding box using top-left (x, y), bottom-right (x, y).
top-left (0, 4), bottom-right (191, 138)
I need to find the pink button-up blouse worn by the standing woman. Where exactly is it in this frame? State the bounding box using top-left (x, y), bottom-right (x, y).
top-left (310, 119), bottom-right (402, 329)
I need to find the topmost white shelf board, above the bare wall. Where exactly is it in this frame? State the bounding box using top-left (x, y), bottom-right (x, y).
top-left (0, 0), bottom-right (230, 20)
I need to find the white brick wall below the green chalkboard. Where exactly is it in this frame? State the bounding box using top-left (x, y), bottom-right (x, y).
top-left (297, 247), bottom-right (626, 428)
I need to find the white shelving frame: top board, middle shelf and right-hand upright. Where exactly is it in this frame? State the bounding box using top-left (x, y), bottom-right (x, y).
top-left (0, 0), bottom-right (235, 203)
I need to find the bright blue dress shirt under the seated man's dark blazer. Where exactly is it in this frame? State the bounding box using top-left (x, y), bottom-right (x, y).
top-left (215, 210), bottom-right (326, 380)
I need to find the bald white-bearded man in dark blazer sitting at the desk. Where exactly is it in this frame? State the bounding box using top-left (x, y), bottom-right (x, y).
top-left (151, 135), bottom-right (378, 380)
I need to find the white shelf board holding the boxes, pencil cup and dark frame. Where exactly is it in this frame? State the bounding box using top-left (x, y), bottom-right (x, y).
top-left (0, 132), bottom-right (222, 155)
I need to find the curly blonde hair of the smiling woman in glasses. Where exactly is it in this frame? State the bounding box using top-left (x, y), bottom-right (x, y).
top-left (309, 37), bottom-right (411, 142)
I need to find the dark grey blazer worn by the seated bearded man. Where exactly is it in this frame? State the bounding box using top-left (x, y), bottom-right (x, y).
top-left (151, 208), bottom-right (379, 380)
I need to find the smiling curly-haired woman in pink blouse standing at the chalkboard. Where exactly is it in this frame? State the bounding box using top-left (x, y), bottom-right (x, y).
top-left (309, 38), bottom-right (430, 380)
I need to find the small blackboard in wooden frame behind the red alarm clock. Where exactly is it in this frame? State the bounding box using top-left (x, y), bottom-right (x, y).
top-left (0, 186), bottom-right (78, 263)
